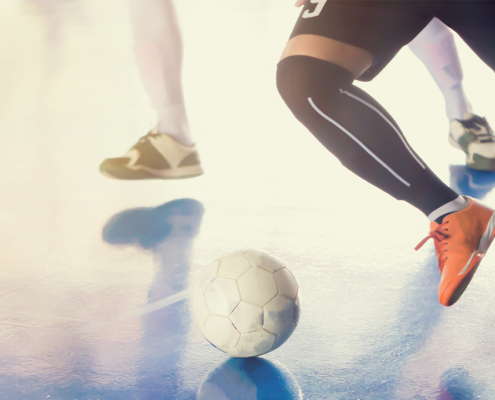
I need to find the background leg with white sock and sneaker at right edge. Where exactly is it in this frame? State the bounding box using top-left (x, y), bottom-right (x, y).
top-left (409, 18), bottom-right (495, 171)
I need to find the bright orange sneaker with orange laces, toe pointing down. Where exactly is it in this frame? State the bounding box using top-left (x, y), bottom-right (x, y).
top-left (416, 196), bottom-right (495, 307)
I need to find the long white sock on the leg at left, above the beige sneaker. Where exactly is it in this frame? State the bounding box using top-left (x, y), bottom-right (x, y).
top-left (130, 0), bottom-right (193, 146)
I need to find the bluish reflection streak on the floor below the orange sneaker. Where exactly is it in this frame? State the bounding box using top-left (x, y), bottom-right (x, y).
top-left (312, 257), bottom-right (443, 400)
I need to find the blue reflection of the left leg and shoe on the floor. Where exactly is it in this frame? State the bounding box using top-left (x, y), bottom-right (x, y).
top-left (103, 199), bottom-right (204, 399)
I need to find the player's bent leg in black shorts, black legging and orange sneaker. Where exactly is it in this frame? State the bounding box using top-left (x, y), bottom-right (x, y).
top-left (277, 0), bottom-right (493, 305)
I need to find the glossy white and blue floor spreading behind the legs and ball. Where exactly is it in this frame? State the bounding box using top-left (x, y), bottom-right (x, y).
top-left (0, 0), bottom-right (495, 400)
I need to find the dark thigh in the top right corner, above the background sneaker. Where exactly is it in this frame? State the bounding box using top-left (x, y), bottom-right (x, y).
top-left (436, 1), bottom-right (495, 71)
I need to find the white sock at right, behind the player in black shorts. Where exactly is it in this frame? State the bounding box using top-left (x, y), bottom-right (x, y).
top-left (409, 18), bottom-right (472, 121)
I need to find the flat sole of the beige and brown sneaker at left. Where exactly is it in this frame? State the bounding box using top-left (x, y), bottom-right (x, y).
top-left (100, 165), bottom-right (204, 180)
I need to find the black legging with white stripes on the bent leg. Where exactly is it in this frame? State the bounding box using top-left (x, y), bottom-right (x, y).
top-left (277, 56), bottom-right (459, 216)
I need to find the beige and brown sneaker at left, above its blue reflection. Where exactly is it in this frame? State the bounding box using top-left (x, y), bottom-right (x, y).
top-left (100, 128), bottom-right (203, 179)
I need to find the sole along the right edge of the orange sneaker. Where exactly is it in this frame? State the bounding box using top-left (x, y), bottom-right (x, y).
top-left (439, 209), bottom-right (495, 307)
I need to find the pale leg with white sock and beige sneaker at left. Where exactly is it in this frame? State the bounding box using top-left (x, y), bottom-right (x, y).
top-left (100, 0), bottom-right (203, 179)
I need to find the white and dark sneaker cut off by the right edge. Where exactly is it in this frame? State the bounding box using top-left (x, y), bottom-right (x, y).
top-left (449, 114), bottom-right (495, 171)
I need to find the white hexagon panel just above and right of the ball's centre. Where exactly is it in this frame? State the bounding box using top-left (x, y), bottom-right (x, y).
top-left (237, 267), bottom-right (278, 306)
